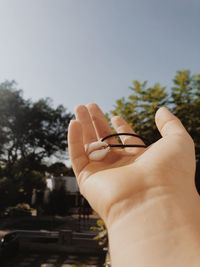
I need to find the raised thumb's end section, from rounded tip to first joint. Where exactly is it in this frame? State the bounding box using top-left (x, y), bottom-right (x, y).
top-left (155, 107), bottom-right (188, 136)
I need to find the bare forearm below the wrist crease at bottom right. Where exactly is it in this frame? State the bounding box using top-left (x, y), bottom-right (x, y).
top-left (108, 191), bottom-right (200, 267)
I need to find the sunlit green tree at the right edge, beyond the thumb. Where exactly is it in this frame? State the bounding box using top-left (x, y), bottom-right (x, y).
top-left (170, 70), bottom-right (200, 157)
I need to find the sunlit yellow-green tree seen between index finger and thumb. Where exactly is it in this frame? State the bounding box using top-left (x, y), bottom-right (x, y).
top-left (111, 80), bottom-right (167, 144)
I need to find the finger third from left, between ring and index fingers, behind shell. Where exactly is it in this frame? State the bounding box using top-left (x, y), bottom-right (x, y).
top-left (87, 104), bottom-right (118, 143)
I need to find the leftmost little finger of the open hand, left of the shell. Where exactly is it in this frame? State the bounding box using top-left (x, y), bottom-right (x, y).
top-left (68, 120), bottom-right (88, 177)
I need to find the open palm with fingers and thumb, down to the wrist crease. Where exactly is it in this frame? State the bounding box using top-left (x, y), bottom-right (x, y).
top-left (68, 104), bottom-right (197, 226)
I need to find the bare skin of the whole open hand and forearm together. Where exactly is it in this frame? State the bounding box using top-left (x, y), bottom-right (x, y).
top-left (68, 104), bottom-right (200, 267)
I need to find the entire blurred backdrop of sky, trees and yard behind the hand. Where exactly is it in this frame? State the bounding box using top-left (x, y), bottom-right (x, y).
top-left (0, 0), bottom-right (200, 267)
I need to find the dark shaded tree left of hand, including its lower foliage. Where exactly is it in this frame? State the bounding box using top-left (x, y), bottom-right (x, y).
top-left (0, 81), bottom-right (72, 210)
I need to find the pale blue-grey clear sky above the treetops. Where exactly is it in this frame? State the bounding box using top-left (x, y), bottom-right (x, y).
top-left (0, 0), bottom-right (200, 112)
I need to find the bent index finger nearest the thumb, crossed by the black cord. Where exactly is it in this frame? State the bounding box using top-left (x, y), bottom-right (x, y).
top-left (111, 116), bottom-right (144, 145)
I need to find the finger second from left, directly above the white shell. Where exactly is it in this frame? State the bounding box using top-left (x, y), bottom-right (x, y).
top-left (75, 105), bottom-right (97, 144)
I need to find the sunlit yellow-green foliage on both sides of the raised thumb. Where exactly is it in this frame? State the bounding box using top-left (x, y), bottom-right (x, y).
top-left (110, 70), bottom-right (200, 159)
